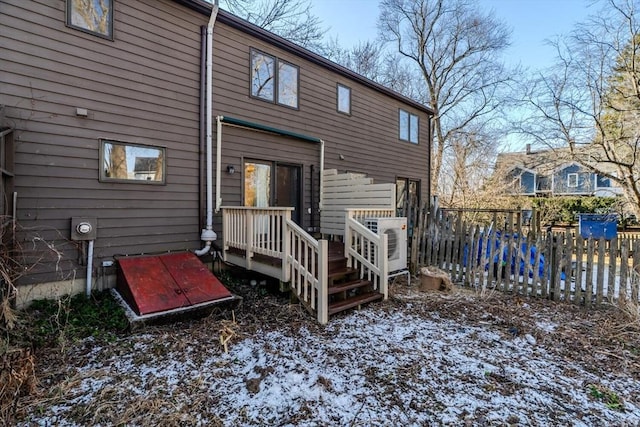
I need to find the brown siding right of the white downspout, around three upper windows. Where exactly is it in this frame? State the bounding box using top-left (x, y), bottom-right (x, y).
top-left (213, 23), bottom-right (429, 212)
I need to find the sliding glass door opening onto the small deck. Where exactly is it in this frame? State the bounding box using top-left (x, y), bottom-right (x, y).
top-left (244, 160), bottom-right (302, 225)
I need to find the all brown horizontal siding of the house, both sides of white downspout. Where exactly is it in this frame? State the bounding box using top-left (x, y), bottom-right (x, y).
top-left (0, 0), bottom-right (430, 290)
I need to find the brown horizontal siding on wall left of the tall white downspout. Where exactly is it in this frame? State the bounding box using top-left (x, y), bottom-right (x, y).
top-left (0, 0), bottom-right (206, 283)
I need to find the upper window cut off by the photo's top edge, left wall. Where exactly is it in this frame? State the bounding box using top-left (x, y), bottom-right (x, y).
top-left (67, 0), bottom-right (115, 40)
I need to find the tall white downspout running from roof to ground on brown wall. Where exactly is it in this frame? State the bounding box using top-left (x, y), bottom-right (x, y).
top-left (195, 0), bottom-right (218, 256)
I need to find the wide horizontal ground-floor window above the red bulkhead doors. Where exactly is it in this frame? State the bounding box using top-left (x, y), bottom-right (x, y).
top-left (100, 140), bottom-right (166, 184)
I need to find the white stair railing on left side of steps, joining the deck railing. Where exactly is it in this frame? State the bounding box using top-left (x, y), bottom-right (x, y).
top-left (283, 219), bottom-right (329, 325)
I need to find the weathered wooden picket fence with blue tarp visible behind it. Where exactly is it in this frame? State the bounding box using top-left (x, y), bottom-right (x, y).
top-left (412, 207), bottom-right (640, 306)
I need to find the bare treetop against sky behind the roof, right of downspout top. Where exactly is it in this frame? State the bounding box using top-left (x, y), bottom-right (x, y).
top-left (221, 0), bottom-right (326, 50)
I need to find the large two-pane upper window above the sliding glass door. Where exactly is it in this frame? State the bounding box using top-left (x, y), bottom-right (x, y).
top-left (251, 50), bottom-right (299, 108)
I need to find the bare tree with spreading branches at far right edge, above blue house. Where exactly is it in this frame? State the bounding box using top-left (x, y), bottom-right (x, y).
top-left (522, 0), bottom-right (640, 214)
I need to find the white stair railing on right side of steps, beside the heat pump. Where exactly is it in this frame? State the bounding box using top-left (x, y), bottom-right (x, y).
top-left (344, 214), bottom-right (389, 300)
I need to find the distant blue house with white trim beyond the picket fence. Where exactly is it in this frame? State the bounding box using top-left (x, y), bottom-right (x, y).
top-left (496, 148), bottom-right (622, 197)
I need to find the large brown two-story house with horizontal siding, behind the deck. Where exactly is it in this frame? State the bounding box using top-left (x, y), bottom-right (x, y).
top-left (0, 0), bottom-right (432, 320)
